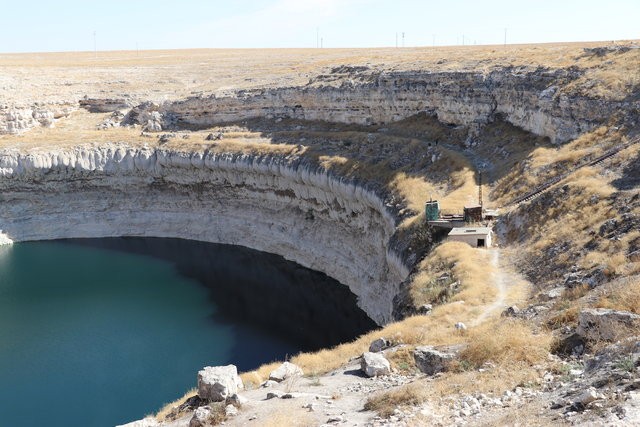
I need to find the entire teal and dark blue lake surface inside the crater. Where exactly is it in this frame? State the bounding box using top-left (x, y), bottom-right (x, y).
top-left (0, 238), bottom-right (375, 426)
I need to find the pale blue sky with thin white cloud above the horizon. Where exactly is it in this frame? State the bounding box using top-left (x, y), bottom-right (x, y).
top-left (0, 0), bottom-right (640, 52)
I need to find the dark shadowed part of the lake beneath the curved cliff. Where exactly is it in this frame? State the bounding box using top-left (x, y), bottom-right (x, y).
top-left (66, 237), bottom-right (376, 370)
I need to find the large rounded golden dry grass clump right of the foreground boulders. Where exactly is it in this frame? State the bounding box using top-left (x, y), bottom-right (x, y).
top-left (460, 319), bottom-right (551, 367)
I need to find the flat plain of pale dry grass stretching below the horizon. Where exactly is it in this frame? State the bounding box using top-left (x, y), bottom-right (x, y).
top-left (0, 42), bottom-right (640, 107)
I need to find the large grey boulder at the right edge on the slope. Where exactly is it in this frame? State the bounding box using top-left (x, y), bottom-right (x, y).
top-left (576, 308), bottom-right (640, 341)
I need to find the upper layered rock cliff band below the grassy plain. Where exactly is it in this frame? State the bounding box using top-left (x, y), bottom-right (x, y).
top-left (162, 69), bottom-right (622, 143)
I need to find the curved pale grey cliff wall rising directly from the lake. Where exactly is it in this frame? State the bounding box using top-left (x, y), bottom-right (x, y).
top-left (0, 145), bottom-right (408, 324)
